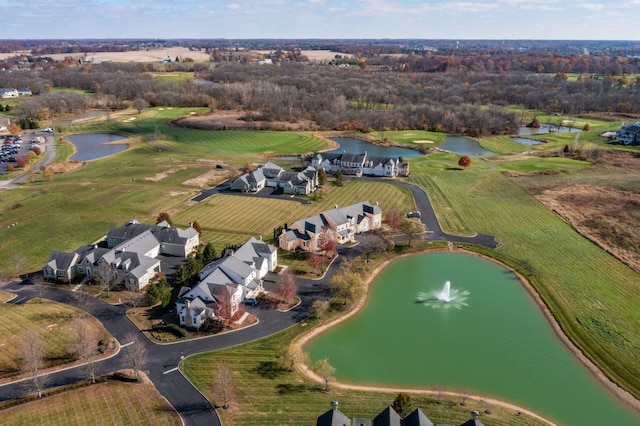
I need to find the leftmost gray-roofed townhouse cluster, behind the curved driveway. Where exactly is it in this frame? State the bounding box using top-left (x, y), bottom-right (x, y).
top-left (42, 220), bottom-right (200, 291)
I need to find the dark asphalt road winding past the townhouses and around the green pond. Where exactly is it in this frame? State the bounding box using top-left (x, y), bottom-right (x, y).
top-left (0, 181), bottom-right (497, 426)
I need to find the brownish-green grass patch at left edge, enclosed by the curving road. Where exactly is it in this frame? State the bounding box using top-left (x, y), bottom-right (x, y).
top-left (0, 299), bottom-right (108, 379)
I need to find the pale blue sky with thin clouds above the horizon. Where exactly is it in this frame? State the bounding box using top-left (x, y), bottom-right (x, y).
top-left (5, 0), bottom-right (640, 40)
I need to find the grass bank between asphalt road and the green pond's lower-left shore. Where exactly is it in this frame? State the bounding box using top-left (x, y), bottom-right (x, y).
top-left (181, 323), bottom-right (545, 426)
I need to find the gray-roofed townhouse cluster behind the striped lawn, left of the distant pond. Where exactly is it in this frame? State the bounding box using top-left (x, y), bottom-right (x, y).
top-left (230, 161), bottom-right (318, 195)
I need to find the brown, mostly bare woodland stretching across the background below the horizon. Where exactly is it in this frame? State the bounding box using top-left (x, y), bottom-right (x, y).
top-left (0, 38), bottom-right (640, 136)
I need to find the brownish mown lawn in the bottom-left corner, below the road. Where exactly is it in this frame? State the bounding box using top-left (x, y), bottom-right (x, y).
top-left (0, 381), bottom-right (181, 426)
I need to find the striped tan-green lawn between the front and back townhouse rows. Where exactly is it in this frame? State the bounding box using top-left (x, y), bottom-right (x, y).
top-left (174, 179), bottom-right (415, 250)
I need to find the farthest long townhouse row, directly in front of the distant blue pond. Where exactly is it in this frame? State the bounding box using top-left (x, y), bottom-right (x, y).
top-left (306, 151), bottom-right (409, 177)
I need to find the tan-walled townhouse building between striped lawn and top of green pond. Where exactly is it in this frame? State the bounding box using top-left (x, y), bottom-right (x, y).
top-left (278, 201), bottom-right (382, 252)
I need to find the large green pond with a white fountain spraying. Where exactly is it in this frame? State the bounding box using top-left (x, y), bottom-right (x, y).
top-left (305, 252), bottom-right (640, 426)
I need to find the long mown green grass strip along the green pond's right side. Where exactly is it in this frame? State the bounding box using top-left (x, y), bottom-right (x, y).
top-left (412, 170), bottom-right (640, 398)
